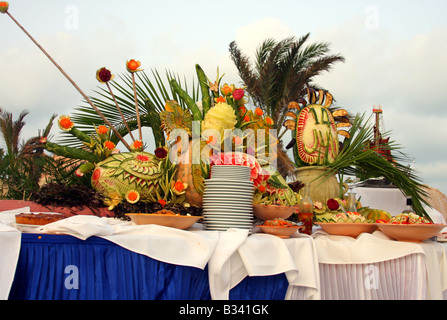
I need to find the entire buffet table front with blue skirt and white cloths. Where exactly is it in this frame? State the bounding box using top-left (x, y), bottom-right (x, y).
top-left (0, 205), bottom-right (447, 300)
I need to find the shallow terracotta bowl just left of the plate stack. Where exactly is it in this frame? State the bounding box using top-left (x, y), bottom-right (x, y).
top-left (126, 213), bottom-right (203, 230)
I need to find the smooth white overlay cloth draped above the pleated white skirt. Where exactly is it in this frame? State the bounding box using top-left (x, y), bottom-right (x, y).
top-left (312, 230), bottom-right (424, 264)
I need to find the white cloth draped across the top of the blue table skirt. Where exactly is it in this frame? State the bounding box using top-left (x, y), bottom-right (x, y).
top-left (0, 210), bottom-right (319, 300)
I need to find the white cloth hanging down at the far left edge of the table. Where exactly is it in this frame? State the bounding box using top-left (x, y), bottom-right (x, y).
top-left (0, 222), bottom-right (22, 300)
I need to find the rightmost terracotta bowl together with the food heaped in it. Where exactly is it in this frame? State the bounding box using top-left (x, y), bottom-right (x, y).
top-left (377, 213), bottom-right (446, 242)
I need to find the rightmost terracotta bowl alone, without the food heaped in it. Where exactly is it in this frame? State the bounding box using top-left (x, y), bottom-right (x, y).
top-left (378, 223), bottom-right (447, 242)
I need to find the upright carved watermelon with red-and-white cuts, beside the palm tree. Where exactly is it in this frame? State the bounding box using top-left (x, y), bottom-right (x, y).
top-left (284, 89), bottom-right (339, 165)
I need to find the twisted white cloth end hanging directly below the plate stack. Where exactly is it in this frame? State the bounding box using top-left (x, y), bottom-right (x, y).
top-left (208, 228), bottom-right (248, 300)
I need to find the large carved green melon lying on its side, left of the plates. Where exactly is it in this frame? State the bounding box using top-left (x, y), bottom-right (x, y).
top-left (92, 152), bottom-right (165, 207)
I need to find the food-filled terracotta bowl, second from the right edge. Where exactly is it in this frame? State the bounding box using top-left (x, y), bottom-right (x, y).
top-left (316, 212), bottom-right (377, 238)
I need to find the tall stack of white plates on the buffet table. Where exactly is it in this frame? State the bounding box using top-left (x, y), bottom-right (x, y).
top-left (203, 165), bottom-right (254, 231)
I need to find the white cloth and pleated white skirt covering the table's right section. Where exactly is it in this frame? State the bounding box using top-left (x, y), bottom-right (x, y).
top-left (312, 230), bottom-right (447, 300)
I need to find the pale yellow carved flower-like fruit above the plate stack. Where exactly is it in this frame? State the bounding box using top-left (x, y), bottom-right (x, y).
top-left (202, 102), bottom-right (237, 139)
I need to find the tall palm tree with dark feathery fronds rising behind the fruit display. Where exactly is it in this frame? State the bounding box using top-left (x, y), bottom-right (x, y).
top-left (230, 33), bottom-right (344, 177)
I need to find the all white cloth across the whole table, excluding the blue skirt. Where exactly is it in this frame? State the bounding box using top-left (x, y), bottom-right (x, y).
top-left (0, 209), bottom-right (447, 300)
